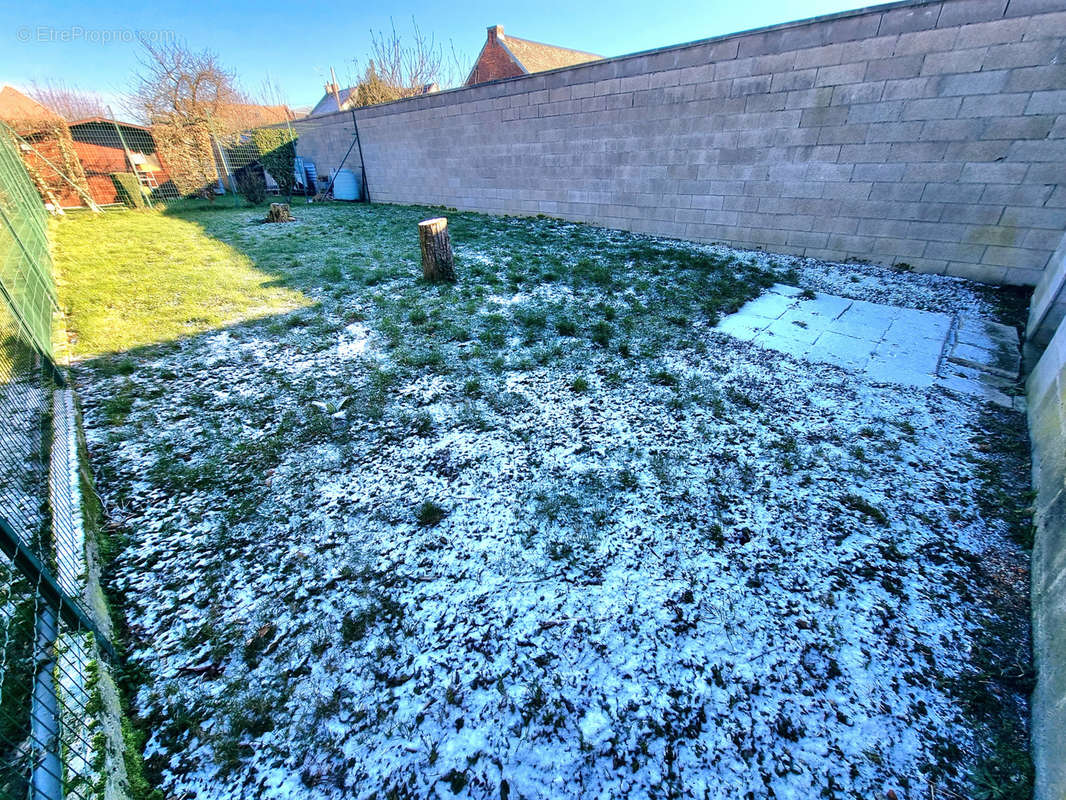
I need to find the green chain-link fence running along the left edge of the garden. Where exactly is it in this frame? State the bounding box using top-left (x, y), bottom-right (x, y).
top-left (0, 120), bottom-right (125, 800)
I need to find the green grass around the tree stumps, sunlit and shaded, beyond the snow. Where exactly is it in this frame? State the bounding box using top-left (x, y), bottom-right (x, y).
top-left (52, 203), bottom-right (774, 407)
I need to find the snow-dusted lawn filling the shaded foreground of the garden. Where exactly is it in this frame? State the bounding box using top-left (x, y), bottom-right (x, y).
top-left (70, 211), bottom-right (1028, 800)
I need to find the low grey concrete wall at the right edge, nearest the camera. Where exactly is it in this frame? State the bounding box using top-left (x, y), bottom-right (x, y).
top-left (1025, 311), bottom-right (1066, 800)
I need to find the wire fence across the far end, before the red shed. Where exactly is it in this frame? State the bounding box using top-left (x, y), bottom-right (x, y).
top-left (1, 107), bottom-right (368, 211)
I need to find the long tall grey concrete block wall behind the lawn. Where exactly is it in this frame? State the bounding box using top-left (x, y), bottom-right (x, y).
top-left (301, 0), bottom-right (1066, 285)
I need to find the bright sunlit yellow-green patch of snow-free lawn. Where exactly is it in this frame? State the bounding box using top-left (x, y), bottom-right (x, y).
top-left (51, 211), bottom-right (311, 357)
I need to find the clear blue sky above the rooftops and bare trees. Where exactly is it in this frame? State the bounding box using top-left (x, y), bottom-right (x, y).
top-left (0, 0), bottom-right (874, 112)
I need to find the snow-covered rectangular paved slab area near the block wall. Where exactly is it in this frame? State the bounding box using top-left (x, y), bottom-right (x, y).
top-left (717, 284), bottom-right (1024, 409)
